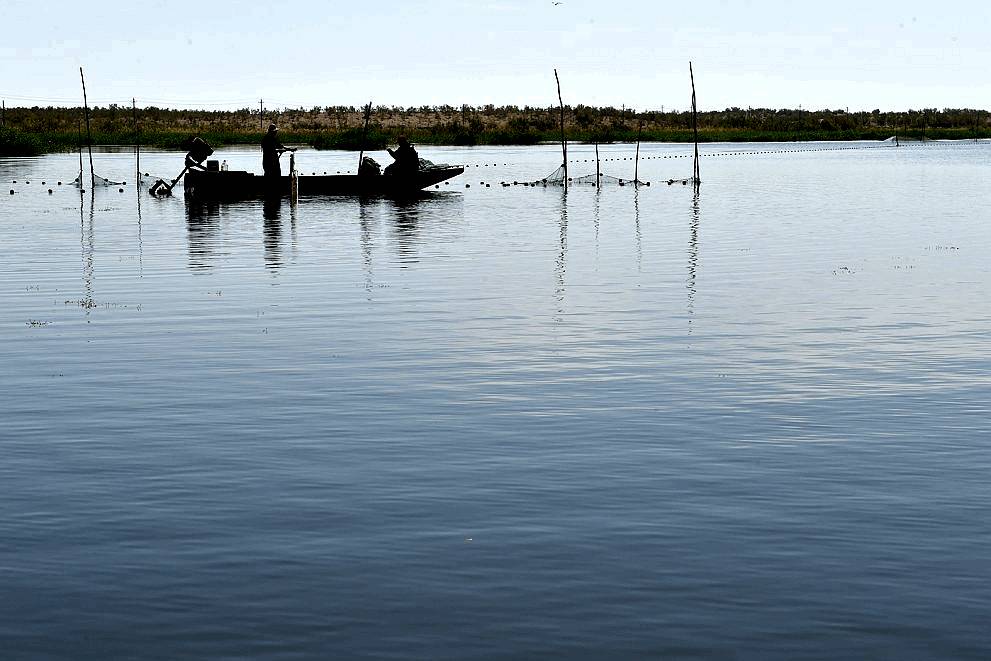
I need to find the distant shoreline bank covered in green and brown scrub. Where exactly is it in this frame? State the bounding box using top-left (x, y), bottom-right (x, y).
top-left (0, 104), bottom-right (991, 155)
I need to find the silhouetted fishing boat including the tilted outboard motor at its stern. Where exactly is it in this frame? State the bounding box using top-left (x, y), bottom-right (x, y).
top-left (149, 138), bottom-right (464, 200)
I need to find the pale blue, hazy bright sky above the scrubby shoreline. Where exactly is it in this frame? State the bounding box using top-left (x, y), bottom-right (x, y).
top-left (0, 0), bottom-right (991, 111)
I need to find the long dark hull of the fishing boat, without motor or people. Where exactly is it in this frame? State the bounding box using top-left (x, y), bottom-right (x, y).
top-left (183, 167), bottom-right (464, 200)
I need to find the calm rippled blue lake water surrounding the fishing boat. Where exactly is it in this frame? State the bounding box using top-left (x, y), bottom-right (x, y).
top-left (0, 143), bottom-right (991, 660)
